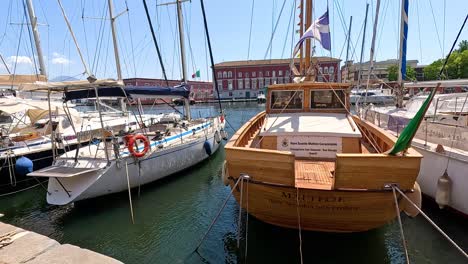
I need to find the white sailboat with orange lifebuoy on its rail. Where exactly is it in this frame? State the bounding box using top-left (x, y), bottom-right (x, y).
top-left (29, 0), bottom-right (226, 205)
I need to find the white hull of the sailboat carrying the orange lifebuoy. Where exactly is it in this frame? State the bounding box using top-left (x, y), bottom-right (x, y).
top-left (41, 117), bottom-right (222, 205)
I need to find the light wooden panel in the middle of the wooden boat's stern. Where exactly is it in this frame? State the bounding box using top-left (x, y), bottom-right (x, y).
top-left (294, 160), bottom-right (335, 190)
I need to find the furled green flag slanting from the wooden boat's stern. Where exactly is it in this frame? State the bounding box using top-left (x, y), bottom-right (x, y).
top-left (389, 83), bottom-right (440, 155)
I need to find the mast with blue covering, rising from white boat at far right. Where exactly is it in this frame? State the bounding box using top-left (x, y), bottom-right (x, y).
top-left (396, 0), bottom-right (408, 108)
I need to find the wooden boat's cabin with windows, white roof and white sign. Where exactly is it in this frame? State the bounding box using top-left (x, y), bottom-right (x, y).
top-left (257, 83), bottom-right (362, 157)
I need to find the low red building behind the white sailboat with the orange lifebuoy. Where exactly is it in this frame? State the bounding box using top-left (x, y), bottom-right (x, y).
top-left (123, 78), bottom-right (214, 103)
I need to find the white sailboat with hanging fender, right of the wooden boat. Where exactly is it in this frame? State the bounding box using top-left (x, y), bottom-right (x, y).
top-left (361, 0), bottom-right (468, 216)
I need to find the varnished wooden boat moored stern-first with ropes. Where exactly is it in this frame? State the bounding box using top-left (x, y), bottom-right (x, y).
top-left (224, 82), bottom-right (422, 232)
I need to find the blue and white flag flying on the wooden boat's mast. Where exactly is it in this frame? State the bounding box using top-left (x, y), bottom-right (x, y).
top-left (293, 9), bottom-right (331, 56)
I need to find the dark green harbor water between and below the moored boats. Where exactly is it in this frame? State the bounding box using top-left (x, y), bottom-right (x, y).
top-left (0, 102), bottom-right (468, 264)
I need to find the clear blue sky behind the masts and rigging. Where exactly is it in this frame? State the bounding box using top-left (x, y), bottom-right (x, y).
top-left (0, 0), bottom-right (468, 80)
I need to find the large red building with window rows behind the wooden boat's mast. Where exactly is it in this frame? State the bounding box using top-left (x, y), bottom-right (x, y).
top-left (215, 57), bottom-right (341, 99)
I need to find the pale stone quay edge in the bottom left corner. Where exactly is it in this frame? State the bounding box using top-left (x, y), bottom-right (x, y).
top-left (0, 222), bottom-right (122, 264)
